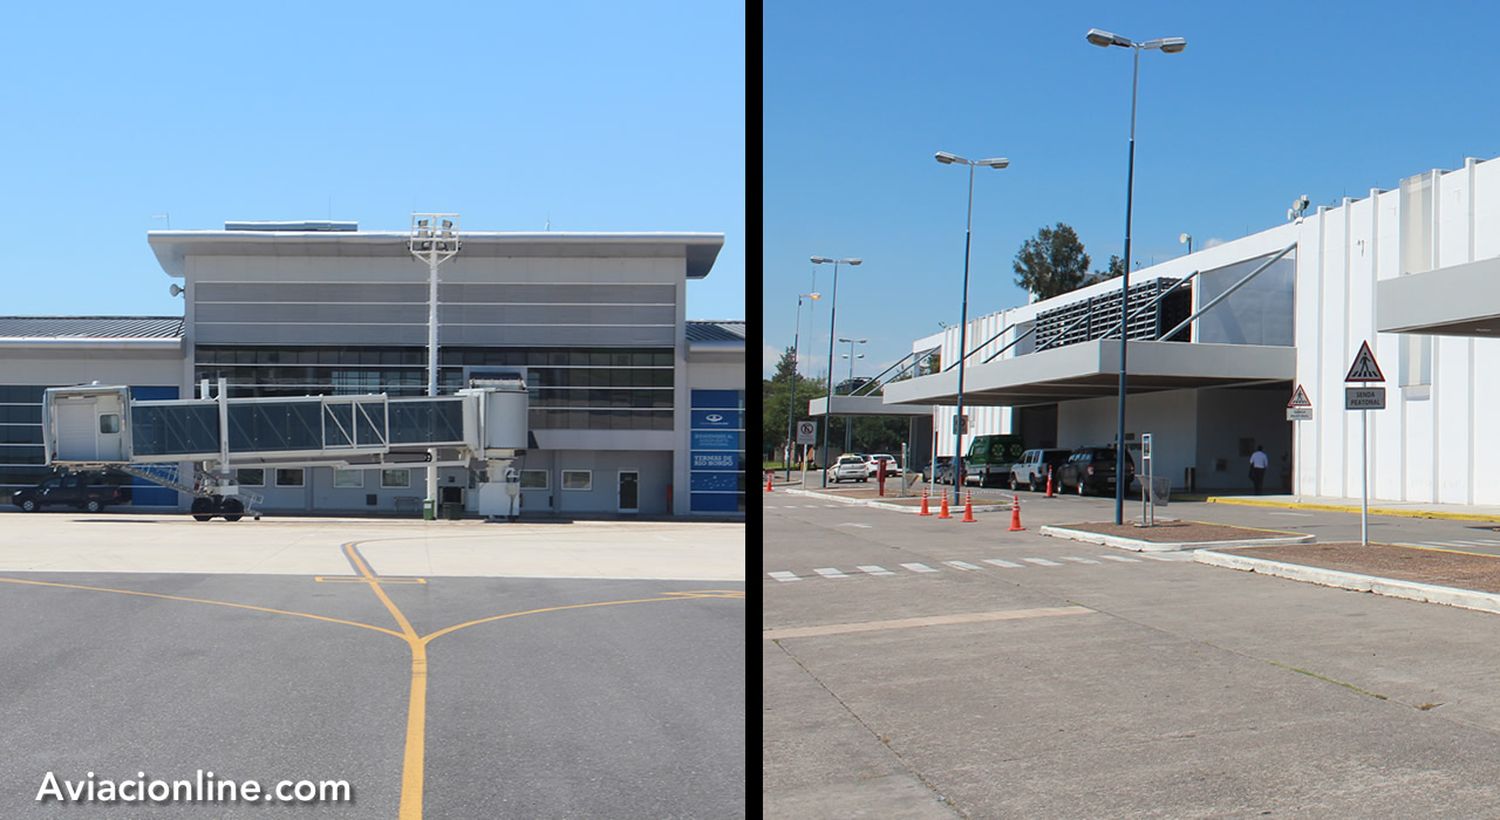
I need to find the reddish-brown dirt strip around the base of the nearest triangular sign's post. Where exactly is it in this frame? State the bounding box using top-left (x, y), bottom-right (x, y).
top-left (1218, 543), bottom-right (1500, 592)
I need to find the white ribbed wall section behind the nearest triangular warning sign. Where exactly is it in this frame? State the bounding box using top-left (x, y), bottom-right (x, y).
top-left (1296, 152), bottom-right (1500, 504)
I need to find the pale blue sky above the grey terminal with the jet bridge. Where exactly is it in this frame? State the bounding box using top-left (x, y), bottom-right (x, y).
top-left (0, 1), bottom-right (747, 319)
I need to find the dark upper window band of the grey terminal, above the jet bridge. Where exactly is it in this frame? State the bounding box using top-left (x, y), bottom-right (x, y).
top-left (194, 345), bottom-right (675, 436)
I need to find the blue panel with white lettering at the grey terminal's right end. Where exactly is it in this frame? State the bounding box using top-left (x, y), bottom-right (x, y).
top-left (689, 390), bottom-right (746, 513)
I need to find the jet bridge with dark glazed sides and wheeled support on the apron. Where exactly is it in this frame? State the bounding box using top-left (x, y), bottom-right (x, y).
top-left (42, 379), bottom-right (528, 520)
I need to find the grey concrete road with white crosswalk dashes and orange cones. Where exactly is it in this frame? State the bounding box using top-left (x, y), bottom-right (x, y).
top-left (761, 495), bottom-right (1500, 817)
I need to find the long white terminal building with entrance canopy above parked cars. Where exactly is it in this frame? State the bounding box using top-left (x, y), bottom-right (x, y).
top-left (884, 150), bottom-right (1500, 504)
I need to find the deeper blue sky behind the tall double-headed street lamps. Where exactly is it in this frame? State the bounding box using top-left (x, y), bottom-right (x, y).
top-left (762, 0), bottom-right (1500, 378)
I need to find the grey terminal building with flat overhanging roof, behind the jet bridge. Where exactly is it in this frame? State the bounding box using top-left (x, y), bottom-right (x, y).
top-left (0, 222), bottom-right (746, 517)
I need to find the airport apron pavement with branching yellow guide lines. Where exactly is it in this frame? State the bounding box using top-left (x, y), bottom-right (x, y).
top-left (0, 516), bottom-right (746, 820)
